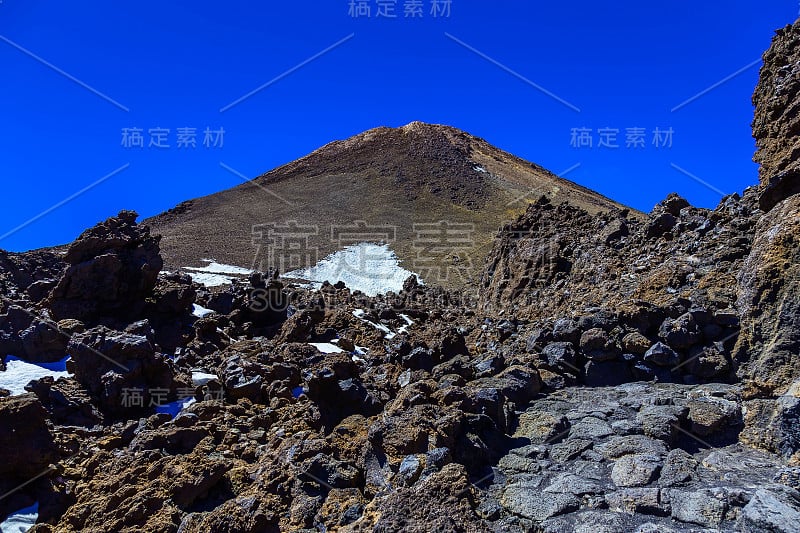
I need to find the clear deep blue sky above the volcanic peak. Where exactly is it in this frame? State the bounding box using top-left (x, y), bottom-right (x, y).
top-left (0, 0), bottom-right (798, 250)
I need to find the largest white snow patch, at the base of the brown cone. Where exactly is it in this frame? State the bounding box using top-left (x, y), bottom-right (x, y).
top-left (282, 242), bottom-right (421, 296)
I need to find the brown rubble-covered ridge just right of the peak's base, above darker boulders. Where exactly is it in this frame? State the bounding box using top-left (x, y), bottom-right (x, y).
top-left (479, 190), bottom-right (760, 319)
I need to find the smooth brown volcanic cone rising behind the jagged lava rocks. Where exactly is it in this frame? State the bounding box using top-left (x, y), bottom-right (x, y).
top-left (146, 122), bottom-right (636, 288)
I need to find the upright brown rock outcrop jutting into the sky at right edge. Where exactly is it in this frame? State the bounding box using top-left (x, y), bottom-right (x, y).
top-left (753, 21), bottom-right (800, 211)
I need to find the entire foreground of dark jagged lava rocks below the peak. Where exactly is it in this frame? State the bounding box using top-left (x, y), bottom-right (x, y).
top-left (0, 18), bottom-right (800, 533)
